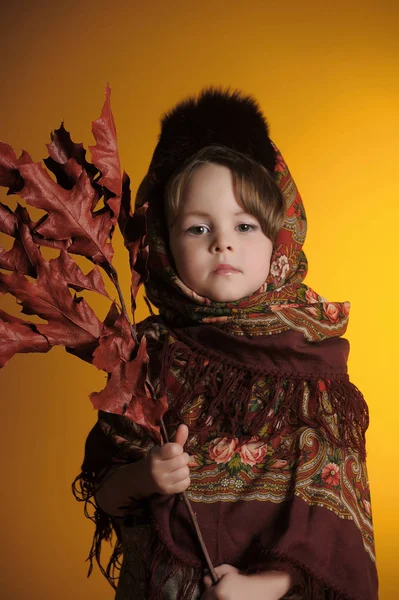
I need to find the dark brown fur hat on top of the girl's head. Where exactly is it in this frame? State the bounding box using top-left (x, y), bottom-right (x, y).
top-left (150, 87), bottom-right (276, 188)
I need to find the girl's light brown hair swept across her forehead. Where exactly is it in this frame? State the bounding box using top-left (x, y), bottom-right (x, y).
top-left (165, 145), bottom-right (285, 241)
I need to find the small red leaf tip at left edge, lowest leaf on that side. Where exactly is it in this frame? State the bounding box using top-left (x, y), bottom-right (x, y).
top-left (0, 310), bottom-right (51, 368)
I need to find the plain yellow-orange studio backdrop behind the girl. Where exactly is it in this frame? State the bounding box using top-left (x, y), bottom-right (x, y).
top-left (0, 0), bottom-right (399, 600)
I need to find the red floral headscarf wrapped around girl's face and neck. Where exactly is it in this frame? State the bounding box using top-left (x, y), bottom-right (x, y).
top-left (136, 138), bottom-right (350, 341)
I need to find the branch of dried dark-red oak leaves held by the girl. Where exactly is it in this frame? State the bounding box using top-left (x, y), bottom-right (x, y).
top-left (0, 86), bottom-right (216, 581)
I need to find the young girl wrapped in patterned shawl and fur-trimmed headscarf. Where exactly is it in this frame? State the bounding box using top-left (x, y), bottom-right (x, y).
top-left (77, 89), bottom-right (377, 600)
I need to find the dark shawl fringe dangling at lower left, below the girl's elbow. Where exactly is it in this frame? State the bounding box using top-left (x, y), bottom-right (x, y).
top-left (72, 471), bottom-right (123, 590)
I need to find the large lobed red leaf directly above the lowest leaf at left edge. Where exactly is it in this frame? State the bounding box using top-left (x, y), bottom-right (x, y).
top-left (0, 211), bottom-right (103, 348)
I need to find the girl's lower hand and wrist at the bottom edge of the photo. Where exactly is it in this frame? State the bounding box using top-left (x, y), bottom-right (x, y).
top-left (201, 565), bottom-right (292, 600)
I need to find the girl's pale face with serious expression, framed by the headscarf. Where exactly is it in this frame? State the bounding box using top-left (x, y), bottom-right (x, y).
top-left (169, 163), bottom-right (273, 302)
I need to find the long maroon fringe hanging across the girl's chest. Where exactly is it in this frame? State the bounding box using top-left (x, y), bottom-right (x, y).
top-left (160, 336), bottom-right (369, 459)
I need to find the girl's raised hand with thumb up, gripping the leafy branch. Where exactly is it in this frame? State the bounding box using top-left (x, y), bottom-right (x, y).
top-left (136, 425), bottom-right (190, 500)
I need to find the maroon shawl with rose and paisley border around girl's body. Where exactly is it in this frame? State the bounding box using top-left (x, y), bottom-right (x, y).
top-left (74, 318), bottom-right (377, 600)
